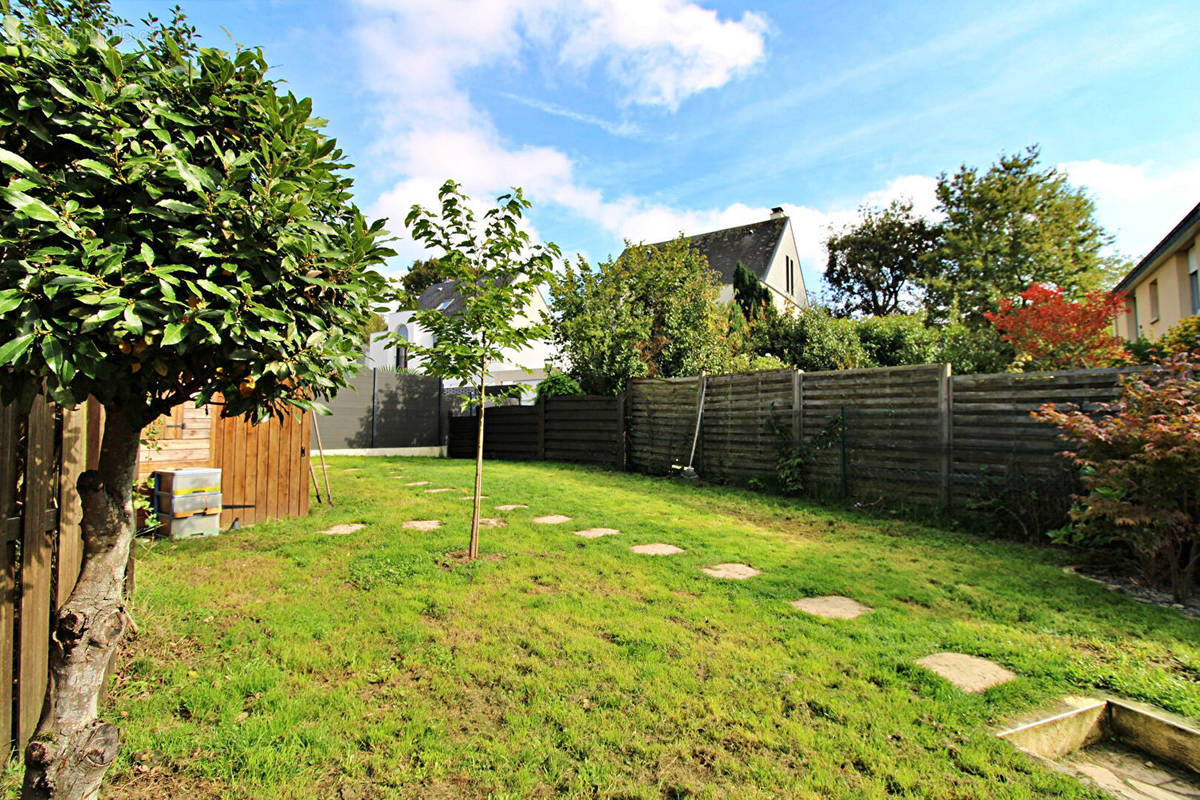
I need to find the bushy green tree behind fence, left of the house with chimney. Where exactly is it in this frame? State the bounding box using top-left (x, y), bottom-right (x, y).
top-left (550, 236), bottom-right (730, 395)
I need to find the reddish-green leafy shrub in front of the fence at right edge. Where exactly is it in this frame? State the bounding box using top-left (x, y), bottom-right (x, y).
top-left (1033, 349), bottom-right (1200, 602)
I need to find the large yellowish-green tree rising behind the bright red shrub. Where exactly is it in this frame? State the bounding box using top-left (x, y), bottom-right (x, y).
top-left (929, 146), bottom-right (1121, 327)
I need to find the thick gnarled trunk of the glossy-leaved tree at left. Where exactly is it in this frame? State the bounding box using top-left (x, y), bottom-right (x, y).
top-left (22, 408), bottom-right (142, 800)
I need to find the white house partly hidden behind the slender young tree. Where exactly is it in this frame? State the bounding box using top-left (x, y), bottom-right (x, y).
top-left (366, 281), bottom-right (552, 387)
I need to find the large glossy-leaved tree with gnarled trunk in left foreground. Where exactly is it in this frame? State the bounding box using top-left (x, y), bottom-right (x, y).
top-left (0, 0), bottom-right (390, 799)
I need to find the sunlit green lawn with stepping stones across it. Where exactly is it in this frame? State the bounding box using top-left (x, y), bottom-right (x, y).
top-left (10, 458), bottom-right (1200, 800)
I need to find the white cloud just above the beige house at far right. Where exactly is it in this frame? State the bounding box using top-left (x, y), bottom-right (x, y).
top-left (1058, 160), bottom-right (1200, 260)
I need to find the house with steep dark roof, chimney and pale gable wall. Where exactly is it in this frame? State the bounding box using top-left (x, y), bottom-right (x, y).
top-left (624, 207), bottom-right (809, 311)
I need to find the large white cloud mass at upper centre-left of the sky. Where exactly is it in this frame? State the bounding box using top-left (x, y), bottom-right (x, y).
top-left (356, 0), bottom-right (767, 259)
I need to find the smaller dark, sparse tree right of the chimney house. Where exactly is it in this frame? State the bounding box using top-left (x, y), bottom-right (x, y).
top-left (826, 200), bottom-right (942, 317)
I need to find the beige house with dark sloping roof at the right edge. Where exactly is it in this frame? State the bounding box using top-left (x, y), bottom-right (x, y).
top-left (1116, 205), bottom-right (1200, 341)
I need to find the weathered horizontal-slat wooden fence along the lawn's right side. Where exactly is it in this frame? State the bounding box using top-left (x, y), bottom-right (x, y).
top-left (450, 365), bottom-right (1127, 524)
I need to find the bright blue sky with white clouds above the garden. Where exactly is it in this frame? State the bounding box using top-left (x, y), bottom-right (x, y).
top-left (114, 0), bottom-right (1200, 296)
